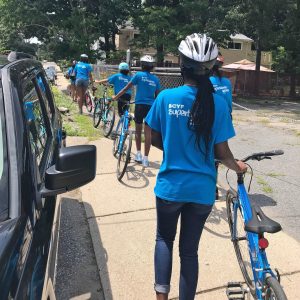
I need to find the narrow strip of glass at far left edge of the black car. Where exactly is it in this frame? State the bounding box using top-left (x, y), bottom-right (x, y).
top-left (0, 87), bottom-right (8, 222)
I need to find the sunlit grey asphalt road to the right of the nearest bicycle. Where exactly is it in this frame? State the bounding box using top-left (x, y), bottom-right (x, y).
top-left (220, 101), bottom-right (300, 241)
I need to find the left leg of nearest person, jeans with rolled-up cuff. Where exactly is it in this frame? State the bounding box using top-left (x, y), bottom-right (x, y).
top-left (154, 197), bottom-right (183, 299)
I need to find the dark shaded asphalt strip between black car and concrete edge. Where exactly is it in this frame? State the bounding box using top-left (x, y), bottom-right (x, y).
top-left (55, 196), bottom-right (104, 300)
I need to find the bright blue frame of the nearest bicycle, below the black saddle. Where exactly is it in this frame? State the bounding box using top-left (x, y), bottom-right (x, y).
top-left (233, 177), bottom-right (277, 300)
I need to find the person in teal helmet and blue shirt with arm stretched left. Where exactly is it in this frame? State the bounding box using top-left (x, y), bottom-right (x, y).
top-left (95, 62), bottom-right (131, 117)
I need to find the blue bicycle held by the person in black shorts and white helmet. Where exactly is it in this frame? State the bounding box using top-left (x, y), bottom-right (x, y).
top-left (113, 102), bottom-right (134, 181)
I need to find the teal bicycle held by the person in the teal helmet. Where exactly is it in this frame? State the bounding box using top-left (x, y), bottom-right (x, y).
top-left (93, 86), bottom-right (116, 137)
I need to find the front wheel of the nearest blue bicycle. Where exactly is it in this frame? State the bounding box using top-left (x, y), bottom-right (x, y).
top-left (226, 192), bottom-right (255, 296)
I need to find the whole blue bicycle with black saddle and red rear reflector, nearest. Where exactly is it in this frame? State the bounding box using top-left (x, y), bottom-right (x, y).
top-left (226, 150), bottom-right (287, 300)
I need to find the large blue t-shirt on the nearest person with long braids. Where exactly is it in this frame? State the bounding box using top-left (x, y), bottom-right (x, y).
top-left (145, 85), bottom-right (235, 205)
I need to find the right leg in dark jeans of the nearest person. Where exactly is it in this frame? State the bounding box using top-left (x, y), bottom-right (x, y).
top-left (179, 203), bottom-right (212, 300)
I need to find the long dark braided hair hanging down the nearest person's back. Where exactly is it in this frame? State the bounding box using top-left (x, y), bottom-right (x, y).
top-left (182, 68), bottom-right (215, 158)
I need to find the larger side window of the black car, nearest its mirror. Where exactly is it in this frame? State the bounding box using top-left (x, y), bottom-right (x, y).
top-left (23, 81), bottom-right (48, 166)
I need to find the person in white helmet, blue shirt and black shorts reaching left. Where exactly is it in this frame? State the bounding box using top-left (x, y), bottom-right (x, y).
top-left (114, 55), bottom-right (160, 167)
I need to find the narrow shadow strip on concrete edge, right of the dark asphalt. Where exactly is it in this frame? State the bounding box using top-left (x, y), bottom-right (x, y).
top-left (84, 202), bottom-right (113, 300)
